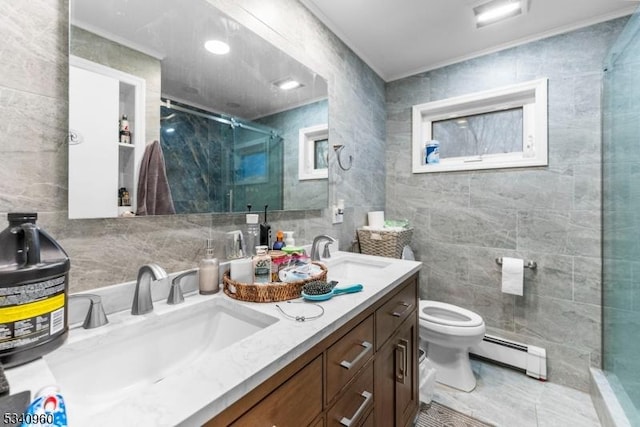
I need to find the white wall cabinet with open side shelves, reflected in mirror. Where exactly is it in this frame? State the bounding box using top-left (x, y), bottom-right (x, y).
top-left (69, 55), bottom-right (146, 219)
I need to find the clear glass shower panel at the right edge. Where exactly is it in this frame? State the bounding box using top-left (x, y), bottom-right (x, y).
top-left (594, 5), bottom-right (640, 426)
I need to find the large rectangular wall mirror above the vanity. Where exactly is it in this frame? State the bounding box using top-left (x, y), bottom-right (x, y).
top-left (69, 0), bottom-right (328, 218)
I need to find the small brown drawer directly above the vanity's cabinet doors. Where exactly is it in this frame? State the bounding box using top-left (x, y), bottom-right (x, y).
top-left (376, 277), bottom-right (418, 350)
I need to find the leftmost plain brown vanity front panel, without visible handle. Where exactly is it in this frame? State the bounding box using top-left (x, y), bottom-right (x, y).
top-left (232, 356), bottom-right (322, 427)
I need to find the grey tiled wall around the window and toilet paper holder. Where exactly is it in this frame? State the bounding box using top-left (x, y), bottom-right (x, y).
top-left (386, 18), bottom-right (626, 390)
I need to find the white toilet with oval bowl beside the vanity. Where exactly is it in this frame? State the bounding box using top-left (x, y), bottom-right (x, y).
top-left (419, 300), bottom-right (486, 392)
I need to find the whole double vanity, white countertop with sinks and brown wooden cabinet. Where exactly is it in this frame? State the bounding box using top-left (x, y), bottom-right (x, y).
top-left (6, 252), bottom-right (420, 426)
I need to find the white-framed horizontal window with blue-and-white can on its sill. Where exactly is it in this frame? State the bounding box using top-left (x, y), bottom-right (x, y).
top-left (412, 78), bottom-right (548, 173)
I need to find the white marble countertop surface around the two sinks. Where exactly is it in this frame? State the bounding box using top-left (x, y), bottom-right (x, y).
top-left (6, 252), bottom-right (421, 427)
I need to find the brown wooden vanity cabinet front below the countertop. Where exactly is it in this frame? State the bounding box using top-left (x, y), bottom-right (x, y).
top-left (206, 274), bottom-right (419, 427)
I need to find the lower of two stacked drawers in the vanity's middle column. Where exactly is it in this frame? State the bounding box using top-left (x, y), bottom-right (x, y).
top-left (327, 362), bottom-right (374, 427)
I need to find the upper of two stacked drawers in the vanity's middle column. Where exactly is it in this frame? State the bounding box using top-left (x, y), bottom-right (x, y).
top-left (327, 315), bottom-right (373, 403)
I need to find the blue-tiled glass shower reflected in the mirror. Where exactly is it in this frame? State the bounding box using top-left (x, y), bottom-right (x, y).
top-left (160, 101), bottom-right (283, 214)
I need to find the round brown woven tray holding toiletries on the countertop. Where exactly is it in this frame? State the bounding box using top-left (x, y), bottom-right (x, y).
top-left (222, 262), bottom-right (327, 302)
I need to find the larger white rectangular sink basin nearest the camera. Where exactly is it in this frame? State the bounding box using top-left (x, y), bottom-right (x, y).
top-left (45, 298), bottom-right (278, 413)
